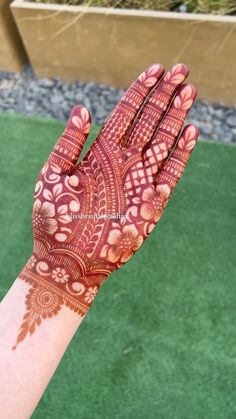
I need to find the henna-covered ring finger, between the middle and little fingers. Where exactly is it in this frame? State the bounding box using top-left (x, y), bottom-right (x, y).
top-left (143, 84), bottom-right (197, 175)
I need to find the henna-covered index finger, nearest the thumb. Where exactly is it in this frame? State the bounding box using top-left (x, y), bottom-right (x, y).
top-left (100, 64), bottom-right (164, 144)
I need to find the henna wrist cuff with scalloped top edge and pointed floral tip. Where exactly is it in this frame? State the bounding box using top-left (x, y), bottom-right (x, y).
top-left (14, 236), bottom-right (110, 350)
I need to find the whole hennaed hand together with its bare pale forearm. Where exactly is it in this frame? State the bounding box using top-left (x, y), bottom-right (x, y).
top-left (0, 64), bottom-right (198, 419)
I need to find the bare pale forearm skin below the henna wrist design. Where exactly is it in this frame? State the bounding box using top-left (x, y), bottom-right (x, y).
top-left (0, 278), bottom-right (82, 419)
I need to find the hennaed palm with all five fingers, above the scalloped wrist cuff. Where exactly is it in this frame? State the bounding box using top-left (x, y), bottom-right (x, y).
top-left (34, 65), bottom-right (197, 276)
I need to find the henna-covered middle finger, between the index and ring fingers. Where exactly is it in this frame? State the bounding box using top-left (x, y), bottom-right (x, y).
top-left (128, 64), bottom-right (189, 151)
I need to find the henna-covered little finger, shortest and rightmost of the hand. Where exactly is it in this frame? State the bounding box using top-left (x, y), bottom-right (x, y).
top-left (154, 125), bottom-right (199, 193)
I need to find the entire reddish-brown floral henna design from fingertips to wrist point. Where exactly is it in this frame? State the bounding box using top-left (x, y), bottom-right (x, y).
top-left (13, 64), bottom-right (198, 349)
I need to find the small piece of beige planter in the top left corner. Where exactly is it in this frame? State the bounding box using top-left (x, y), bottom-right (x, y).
top-left (0, 0), bottom-right (27, 71)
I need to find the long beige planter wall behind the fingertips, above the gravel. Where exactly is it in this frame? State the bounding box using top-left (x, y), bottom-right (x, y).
top-left (13, 4), bottom-right (236, 104)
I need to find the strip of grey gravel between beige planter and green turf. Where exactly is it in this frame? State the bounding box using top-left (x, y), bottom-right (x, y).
top-left (0, 66), bottom-right (236, 143)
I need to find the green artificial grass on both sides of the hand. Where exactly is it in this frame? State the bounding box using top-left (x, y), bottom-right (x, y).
top-left (0, 115), bottom-right (236, 419)
